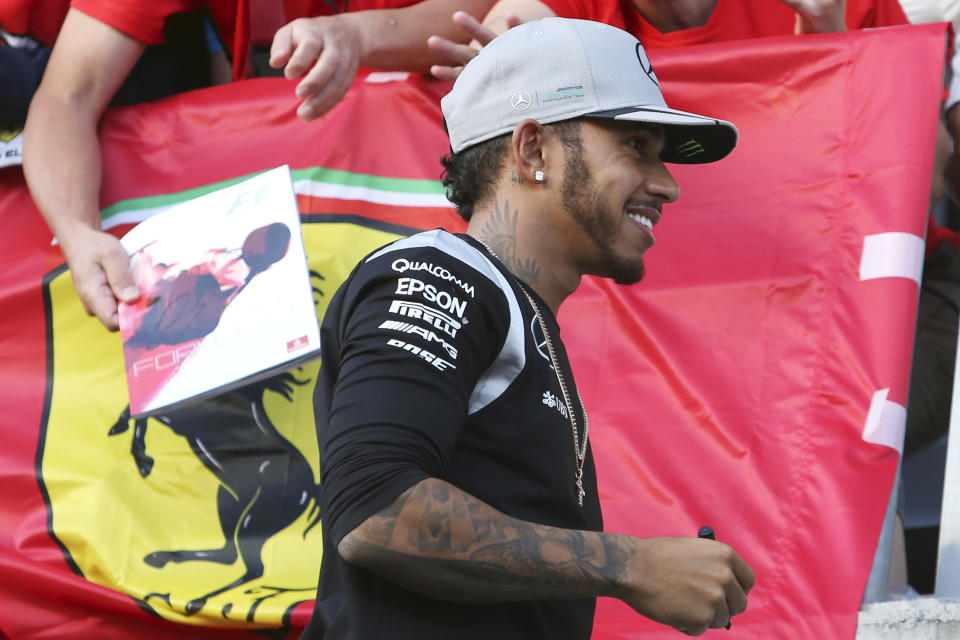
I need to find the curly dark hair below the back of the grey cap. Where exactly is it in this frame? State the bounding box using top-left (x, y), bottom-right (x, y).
top-left (440, 119), bottom-right (583, 222)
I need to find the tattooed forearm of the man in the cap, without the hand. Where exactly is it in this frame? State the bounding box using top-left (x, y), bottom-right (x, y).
top-left (345, 479), bottom-right (634, 602)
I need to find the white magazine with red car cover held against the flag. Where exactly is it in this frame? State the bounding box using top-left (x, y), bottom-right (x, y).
top-left (119, 166), bottom-right (320, 417)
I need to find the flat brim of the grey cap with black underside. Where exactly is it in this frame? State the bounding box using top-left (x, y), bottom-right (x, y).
top-left (583, 106), bottom-right (738, 164)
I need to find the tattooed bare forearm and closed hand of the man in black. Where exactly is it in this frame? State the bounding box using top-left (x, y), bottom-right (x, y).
top-left (337, 478), bottom-right (755, 635)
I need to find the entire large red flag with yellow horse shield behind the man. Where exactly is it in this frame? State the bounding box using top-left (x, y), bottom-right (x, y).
top-left (0, 25), bottom-right (945, 640)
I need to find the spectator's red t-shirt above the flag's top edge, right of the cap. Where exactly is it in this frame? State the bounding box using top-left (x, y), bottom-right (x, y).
top-left (541, 0), bottom-right (907, 49)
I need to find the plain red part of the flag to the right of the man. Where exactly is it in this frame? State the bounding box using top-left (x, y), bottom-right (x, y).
top-left (572, 26), bottom-right (944, 639)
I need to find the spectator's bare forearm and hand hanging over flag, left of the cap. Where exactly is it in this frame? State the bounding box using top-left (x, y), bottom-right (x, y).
top-left (270, 0), bottom-right (494, 120)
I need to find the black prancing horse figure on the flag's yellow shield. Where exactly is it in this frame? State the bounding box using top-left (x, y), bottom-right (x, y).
top-left (108, 373), bottom-right (320, 615)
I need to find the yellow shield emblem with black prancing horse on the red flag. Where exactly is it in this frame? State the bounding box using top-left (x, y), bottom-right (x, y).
top-left (37, 204), bottom-right (410, 637)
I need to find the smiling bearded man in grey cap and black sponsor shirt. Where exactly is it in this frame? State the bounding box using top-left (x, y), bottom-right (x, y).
top-left (303, 18), bottom-right (755, 640)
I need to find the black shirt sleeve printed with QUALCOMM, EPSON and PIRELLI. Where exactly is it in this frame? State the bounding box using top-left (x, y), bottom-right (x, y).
top-left (316, 236), bottom-right (509, 544)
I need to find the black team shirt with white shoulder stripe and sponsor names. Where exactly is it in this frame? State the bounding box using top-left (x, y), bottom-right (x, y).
top-left (302, 230), bottom-right (603, 640)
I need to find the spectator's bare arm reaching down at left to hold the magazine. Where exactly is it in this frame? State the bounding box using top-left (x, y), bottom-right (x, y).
top-left (23, 9), bottom-right (145, 330)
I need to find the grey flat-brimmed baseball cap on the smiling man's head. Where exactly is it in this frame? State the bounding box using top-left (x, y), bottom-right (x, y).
top-left (440, 18), bottom-right (737, 164)
